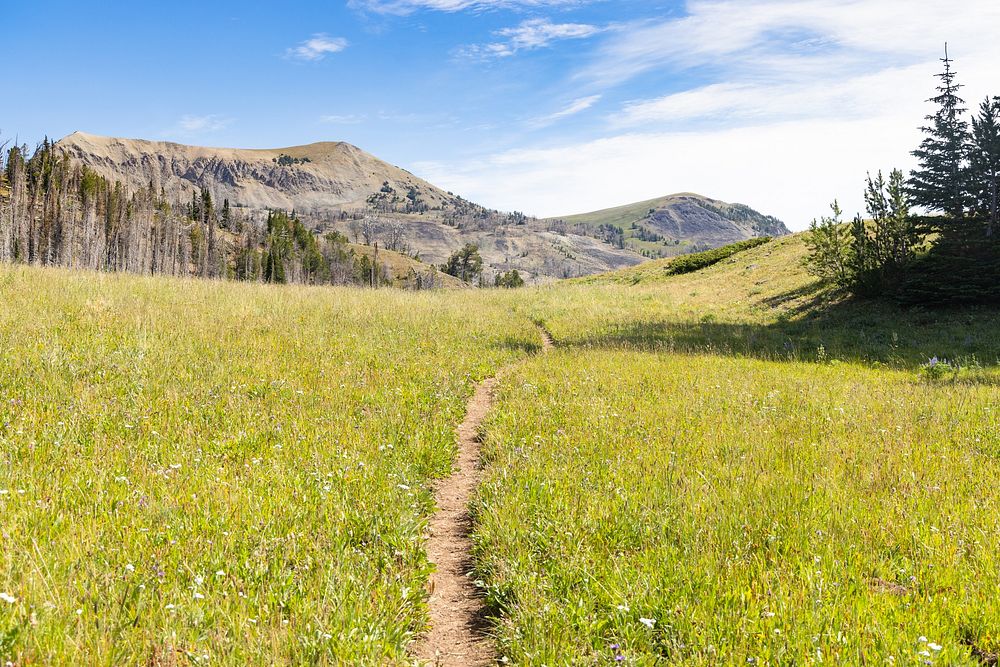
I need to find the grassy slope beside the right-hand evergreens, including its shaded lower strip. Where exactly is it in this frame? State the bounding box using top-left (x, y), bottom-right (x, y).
top-left (522, 235), bottom-right (1000, 369)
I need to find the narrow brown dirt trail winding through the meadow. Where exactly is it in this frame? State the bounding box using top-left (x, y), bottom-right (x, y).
top-left (411, 327), bottom-right (553, 666)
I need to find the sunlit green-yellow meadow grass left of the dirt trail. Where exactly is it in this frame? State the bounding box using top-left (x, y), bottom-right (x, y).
top-left (0, 268), bottom-right (538, 665)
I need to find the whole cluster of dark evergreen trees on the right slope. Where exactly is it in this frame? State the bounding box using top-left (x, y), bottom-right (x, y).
top-left (806, 47), bottom-right (1000, 306)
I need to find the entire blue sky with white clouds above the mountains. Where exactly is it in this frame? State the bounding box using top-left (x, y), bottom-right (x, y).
top-left (0, 0), bottom-right (1000, 229)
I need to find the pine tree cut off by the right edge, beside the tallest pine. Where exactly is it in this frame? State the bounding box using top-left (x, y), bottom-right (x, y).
top-left (969, 97), bottom-right (1000, 236)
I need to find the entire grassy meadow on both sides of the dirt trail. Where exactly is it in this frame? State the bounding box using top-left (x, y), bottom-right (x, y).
top-left (0, 237), bottom-right (1000, 667)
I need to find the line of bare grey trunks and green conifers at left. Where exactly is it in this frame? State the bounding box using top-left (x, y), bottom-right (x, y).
top-left (0, 139), bottom-right (436, 287)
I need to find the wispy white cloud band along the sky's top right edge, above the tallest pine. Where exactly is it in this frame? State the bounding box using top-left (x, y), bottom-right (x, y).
top-left (581, 0), bottom-right (1000, 84)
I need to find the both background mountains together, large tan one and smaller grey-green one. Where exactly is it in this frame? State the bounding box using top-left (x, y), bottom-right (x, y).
top-left (57, 132), bottom-right (787, 282)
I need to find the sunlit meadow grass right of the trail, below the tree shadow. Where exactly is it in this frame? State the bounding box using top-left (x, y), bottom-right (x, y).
top-left (476, 350), bottom-right (1000, 665)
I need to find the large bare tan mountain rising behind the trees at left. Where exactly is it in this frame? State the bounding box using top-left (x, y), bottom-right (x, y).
top-left (57, 132), bottom-right (642, 282)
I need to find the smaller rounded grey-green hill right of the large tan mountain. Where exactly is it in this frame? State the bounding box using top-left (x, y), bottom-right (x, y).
top-left (550, 193), bottom-right (789, 257)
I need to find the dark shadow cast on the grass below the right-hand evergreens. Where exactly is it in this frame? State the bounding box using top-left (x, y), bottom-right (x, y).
top-left (559, 286), bottom-right (1000, 374)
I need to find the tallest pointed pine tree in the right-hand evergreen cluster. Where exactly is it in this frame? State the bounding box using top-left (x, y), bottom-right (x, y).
top-left (907, 45), bottom-right (969, 224)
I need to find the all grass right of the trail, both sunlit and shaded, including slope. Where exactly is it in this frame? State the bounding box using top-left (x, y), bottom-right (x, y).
top-left (475, 237), bottom-right (1000, 665)
